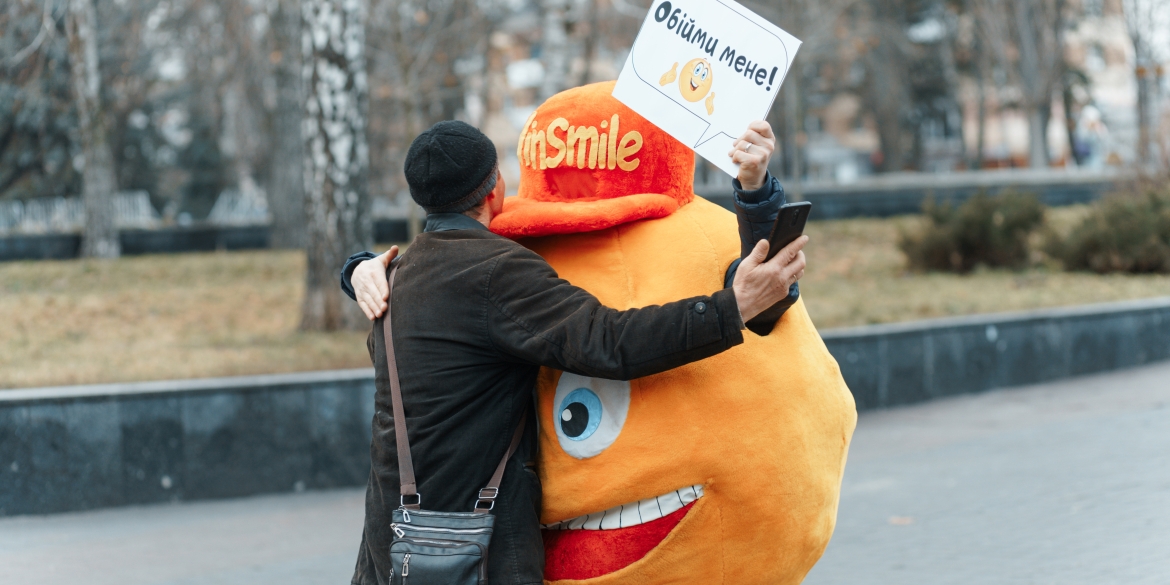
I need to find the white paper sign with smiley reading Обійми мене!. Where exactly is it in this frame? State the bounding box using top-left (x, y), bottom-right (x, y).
top-left (613, 0), bottom-right (800, 177)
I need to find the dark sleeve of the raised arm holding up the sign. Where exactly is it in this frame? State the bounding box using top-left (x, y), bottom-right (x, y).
top-left (723, 172), bottom-right (800, 336)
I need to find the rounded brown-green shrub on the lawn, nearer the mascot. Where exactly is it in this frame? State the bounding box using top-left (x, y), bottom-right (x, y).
top-left (899, 192), bottom-right (1044, 273)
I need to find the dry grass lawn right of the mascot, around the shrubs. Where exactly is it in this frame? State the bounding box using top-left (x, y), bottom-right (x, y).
top-left (800, 206), bottom-right (1170, 329)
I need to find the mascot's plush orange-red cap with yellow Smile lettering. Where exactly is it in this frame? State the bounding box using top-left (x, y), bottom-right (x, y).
top-left (491, 82), bottom-right (695, 238)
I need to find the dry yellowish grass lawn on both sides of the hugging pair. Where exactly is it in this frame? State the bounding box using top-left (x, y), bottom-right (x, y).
top-left (0, 208), bottom-right (1170, 388)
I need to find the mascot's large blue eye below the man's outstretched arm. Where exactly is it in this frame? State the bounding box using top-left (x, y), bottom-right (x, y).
top-left (552, 372), bottom-right (629, 459)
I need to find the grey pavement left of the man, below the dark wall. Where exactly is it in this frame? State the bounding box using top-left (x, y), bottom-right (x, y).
top-left (0, 489), bottom-right (365, 585)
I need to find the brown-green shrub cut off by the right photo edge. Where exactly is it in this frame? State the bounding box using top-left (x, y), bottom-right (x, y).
top-left (1047, 183), bottom-right (1170, 274)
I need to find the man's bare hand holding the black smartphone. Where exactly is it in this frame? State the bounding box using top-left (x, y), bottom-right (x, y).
top-left (731, 235), bottom-right (808, 323)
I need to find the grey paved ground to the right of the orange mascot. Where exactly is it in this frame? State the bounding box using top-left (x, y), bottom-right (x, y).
top-left (805, 363), bottom-right (1170, 585)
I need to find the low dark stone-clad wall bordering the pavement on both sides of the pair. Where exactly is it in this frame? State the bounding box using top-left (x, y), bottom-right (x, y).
top-left (0, 297), bottom-right (1170, 516)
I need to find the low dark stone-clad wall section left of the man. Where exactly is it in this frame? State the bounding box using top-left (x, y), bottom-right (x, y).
top-left (0, 369), bottom-right (373, 516)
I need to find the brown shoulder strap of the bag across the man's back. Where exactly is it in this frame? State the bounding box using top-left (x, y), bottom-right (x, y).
top-left (381, 262), bottom-right (528, 514)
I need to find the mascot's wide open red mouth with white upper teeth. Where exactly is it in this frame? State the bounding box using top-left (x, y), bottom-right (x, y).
top-left (541, 484), bottom-right (703, 581)
